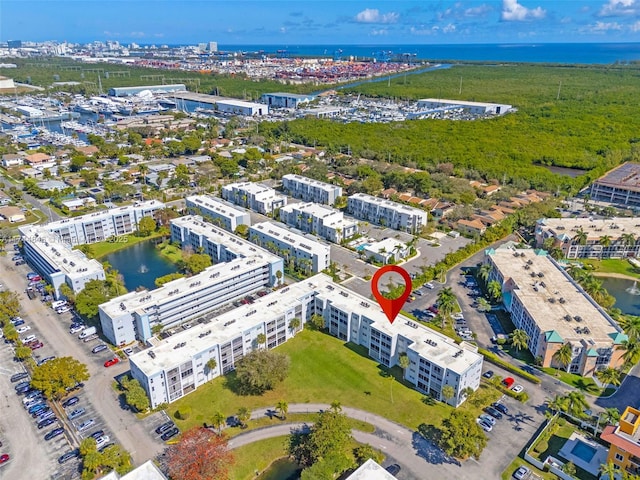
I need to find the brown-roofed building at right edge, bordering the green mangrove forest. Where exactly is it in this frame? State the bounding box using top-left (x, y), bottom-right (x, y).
top-left (589, 162), bottom-right (640, 207)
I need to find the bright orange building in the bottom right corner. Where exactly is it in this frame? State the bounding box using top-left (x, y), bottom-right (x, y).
top-left (600, 407), bottom-right (640, 475)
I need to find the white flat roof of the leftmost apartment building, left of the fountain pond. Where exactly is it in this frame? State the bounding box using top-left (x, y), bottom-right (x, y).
top-left (20, 225), bottom-right (104, 278)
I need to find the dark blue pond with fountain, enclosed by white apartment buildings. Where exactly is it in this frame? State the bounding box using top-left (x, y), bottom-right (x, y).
top-left (101, 240), bottom-right (178, 291)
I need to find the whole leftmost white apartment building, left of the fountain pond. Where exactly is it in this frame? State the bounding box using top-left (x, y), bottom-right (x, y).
top-left (19, 225), bottom-right (105, 299)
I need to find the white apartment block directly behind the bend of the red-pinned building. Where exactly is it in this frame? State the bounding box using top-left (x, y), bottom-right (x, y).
top-left (249, 222), bottom-right (331, 273)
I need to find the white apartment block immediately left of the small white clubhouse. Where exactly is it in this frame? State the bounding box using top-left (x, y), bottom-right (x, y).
top-left (280, 203), bottom-right (358, 243)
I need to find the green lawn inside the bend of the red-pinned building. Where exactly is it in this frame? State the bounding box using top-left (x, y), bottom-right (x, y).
top-left (168, 330), bottom-right (499, 431)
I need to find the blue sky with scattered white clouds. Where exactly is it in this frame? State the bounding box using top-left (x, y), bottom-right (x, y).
top-left (0, 0), bottom-right (640, 47)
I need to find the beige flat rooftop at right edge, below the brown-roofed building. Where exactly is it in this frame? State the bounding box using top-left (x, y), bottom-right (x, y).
top-left (538, 217), bottom-right (640, 240)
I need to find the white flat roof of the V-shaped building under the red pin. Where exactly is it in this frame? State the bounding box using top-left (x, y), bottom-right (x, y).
top-left (131, 273), bottom-right (480, 375)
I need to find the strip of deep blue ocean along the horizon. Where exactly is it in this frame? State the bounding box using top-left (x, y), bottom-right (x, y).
top-left (218, 43), bottom-right (640, 64)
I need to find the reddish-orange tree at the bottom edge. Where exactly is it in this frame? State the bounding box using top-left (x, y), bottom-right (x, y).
top-left (166, 427), bottom-right (234, 480)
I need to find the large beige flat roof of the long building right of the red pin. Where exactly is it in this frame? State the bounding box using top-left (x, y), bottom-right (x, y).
top-left (489, 248), bottom-right (620, 348)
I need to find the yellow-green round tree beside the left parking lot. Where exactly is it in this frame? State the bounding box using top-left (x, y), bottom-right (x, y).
top-left (31, 357), bottom-right (89, 399)
